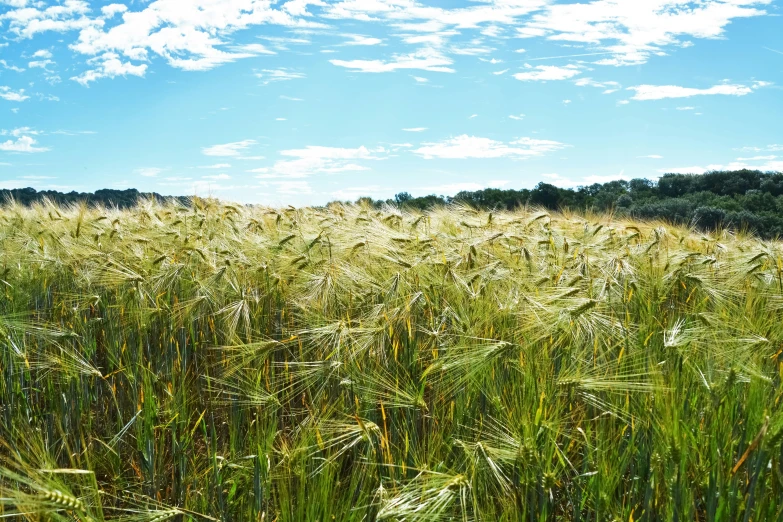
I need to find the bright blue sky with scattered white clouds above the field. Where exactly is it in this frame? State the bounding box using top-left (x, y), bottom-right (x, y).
top-left (0, 0), bottom-right (783, 205)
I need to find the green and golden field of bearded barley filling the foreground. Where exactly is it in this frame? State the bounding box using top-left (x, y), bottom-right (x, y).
top-left (0, 199), bottom-right (783, 522)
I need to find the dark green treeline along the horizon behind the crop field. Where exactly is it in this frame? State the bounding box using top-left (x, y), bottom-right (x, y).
top-left (0, 170), bottom-right (783, 238)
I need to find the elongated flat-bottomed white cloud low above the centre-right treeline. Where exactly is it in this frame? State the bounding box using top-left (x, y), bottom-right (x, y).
top-left (413, 134), bottom-right (567, 159)
